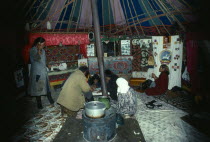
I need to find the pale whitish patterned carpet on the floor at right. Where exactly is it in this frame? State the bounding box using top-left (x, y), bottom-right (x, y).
top-left (135, 93), bottom-right (210, 142)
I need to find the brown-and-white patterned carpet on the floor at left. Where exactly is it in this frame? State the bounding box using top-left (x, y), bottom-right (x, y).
top-left (12, 105), bottom-right (66, 142)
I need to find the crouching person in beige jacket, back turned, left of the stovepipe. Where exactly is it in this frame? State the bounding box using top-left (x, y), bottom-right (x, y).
top-left (57, 66), bottom-right (93, 117)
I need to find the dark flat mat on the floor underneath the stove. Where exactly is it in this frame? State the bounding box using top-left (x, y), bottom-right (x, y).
top-left (53, 117), bottom-right (145, 142)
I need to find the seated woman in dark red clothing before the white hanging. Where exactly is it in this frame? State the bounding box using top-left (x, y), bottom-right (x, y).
top-left (145, 64), bottom-right (169, 96)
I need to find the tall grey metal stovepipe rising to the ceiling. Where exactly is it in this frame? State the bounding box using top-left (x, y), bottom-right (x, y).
top-left (91, 0), bottom-right (108, 96)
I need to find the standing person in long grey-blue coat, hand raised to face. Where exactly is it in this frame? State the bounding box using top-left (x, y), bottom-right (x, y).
top-left (28, 37), bottom-right (54, 109)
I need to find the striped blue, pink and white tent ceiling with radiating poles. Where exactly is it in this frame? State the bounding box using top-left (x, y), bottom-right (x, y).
top-left (24, 0), bottom-right (195, 35)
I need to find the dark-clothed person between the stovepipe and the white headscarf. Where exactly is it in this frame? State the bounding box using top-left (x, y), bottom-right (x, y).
top-left (107, 74), bottom-right (119, 101)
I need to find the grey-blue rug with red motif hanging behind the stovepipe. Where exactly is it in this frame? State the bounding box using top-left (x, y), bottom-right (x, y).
top-left (88, 56), bottom-right (133, 74)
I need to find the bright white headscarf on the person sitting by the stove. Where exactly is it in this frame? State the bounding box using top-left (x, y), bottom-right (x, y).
top-left (116, 77), bottom-right (130, 93)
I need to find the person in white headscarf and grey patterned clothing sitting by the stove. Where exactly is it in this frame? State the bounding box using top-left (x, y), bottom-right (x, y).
top-left (116, 77), bottom-right (137, 117)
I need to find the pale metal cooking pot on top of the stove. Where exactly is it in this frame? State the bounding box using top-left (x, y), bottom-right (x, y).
top-left (85, 101), bottom-right (106, 118)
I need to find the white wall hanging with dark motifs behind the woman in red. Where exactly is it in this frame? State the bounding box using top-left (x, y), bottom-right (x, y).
top-left (152, 35), bottom-right (183, 89)
